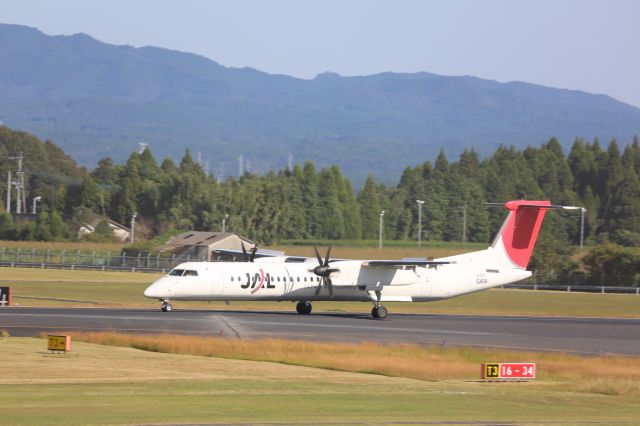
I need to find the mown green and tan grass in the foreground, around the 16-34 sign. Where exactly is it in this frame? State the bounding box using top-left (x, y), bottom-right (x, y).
top-left (0, 337), bottom-right (640, 425)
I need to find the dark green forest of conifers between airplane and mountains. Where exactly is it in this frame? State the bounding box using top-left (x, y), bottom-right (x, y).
top-left (0, 127), bottom-right (640, 286)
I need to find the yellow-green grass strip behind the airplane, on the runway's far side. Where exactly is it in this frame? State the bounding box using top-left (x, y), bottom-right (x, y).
top-left (0, 268), bottom-right (640, 318)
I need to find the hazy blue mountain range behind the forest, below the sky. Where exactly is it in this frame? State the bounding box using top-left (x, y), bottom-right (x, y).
top-left (0, 24), bottom-right (640, 182)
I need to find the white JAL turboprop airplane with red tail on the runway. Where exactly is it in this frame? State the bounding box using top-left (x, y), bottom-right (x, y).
top-left (144, 200), bottom-right (576, 319)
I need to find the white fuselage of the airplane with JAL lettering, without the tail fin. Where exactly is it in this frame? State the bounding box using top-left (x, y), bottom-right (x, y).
top-left (144, 246), bottom-right (531, 302)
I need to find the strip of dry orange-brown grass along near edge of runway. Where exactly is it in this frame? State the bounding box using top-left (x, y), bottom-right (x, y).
top-left (71, 332), bottom-right (640, 396)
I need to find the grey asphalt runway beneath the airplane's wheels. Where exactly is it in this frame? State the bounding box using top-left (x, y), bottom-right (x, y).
top-left (0, 307), bottom-right (640, 356)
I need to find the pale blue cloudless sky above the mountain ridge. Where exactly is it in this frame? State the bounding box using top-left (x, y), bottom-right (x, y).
top-left (0, 0), bottom-right (640, 107)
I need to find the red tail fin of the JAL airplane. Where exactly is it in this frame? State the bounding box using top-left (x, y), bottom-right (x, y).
top-left (492, 200), bottom-right (551, 269)
